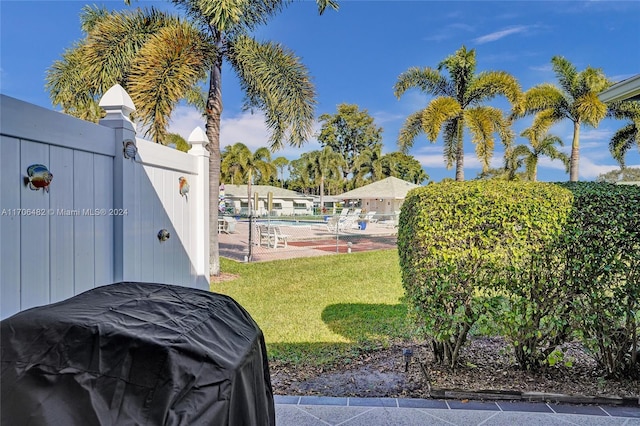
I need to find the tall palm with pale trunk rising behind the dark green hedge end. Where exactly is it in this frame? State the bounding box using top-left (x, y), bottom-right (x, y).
top-left (523, 56), bottom-right (611, 182)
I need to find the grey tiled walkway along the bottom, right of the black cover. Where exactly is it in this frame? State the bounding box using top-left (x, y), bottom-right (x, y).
top-left (275, 395), bottom-right (640, 426)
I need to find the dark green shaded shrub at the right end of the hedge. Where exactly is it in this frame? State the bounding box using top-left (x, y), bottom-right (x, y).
top-left (563, 182), bottom-right (640, 377)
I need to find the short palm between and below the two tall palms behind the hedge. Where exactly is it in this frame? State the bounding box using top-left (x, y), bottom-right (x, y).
top-left (511, 113), bottom-right (569, 182)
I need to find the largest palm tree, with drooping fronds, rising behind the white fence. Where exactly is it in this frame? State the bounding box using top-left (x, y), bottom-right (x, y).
top-left (48, 0), bottom-right (337, 275)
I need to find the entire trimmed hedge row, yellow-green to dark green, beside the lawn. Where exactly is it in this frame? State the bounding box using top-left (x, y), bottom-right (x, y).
top-left (398, 181), bottom-right (640, 375)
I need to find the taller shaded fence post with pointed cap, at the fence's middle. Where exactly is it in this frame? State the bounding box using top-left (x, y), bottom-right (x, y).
top-left (99, 84), bottom-right (136, 282)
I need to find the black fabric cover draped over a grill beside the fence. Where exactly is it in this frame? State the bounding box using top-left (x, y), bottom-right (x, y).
top-left (0, 283), bottom-right (275, 426)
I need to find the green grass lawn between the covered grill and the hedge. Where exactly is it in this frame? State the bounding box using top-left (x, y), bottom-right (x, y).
top-left (211, 249), bottom-right (412, 364)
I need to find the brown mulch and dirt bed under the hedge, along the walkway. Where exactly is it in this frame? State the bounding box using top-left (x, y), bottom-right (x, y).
top-left (270, 338), bottom-right (640, 398)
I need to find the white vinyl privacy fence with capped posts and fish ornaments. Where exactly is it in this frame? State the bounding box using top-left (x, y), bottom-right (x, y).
top-left (0, 85), bottom-right (209, 319)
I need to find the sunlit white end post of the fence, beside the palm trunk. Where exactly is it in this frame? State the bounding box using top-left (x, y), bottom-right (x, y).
top-left (187, 127), bottom-right (209, 289)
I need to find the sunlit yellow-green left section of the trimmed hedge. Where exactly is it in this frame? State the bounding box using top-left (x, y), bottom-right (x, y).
top-left (398, 181), bottom-right (570, 367)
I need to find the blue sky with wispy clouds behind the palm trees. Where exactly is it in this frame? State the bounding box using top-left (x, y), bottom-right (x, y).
top-left (0, 0), bottom-right (640, 181)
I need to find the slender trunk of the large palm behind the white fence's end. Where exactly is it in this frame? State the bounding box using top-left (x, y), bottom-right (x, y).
top-left (206, 45), bottom-right (222, 276)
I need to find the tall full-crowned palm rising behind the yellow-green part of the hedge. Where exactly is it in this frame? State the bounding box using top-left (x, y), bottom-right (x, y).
top-left (394, 46), bottom-right (522, 181)
